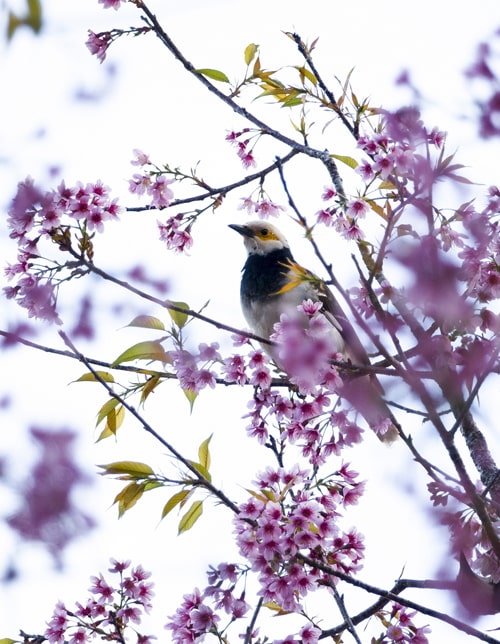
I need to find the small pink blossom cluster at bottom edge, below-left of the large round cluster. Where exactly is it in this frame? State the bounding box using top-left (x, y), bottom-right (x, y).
top-left (165, 563), bottom-right (250, 644)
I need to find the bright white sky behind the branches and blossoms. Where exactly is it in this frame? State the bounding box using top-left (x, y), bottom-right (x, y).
top-left (0, 0), bottom-right (500, 644)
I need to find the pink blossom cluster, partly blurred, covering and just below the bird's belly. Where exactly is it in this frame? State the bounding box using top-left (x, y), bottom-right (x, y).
top-left (222, 301), bottom-right (361, 466)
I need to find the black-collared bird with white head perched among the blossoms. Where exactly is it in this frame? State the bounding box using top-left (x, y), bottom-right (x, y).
top-left (229, 220), bottom-right (399, 443)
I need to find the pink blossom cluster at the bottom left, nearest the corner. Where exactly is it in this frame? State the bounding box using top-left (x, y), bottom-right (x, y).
top-left (44, 559), bottom-right (156, 644)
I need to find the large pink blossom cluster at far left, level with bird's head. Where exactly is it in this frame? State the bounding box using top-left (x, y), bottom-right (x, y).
top-left (4, 177), bottom-right (122, 323)
